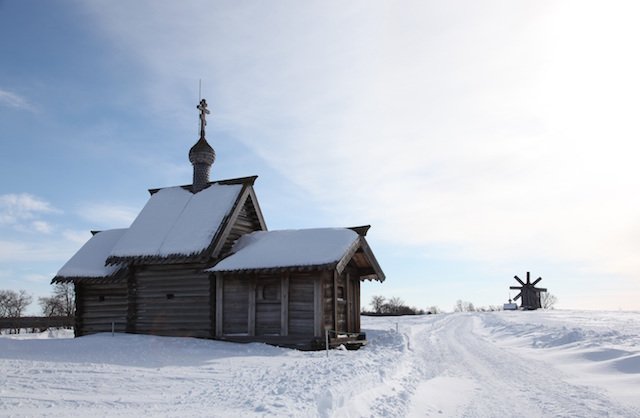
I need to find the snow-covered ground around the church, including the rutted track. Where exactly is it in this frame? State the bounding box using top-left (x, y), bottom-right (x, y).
top-left (0, 311), bottom-right (640, 417)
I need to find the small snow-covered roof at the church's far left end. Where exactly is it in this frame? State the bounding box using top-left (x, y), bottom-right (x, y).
top-left (53, 229), bottom-right (127, 283)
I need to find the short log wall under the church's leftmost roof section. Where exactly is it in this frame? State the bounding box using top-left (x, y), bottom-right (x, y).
top-left (75, 281), bottom-right (128, 337)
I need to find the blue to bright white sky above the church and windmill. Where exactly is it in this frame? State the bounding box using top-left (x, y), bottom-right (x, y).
top-left (0, 0), bottom-right (640, 311)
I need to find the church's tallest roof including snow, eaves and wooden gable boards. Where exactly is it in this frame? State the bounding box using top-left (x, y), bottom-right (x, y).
top-left (107, 176), bottom-right (266, 264)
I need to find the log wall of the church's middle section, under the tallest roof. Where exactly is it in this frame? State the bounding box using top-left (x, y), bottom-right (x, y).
top-left (135, 266), bottom-right (211, 338)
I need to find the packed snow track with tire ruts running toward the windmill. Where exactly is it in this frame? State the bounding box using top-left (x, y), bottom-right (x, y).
top-left (400, 314), bottom-right (637, 417)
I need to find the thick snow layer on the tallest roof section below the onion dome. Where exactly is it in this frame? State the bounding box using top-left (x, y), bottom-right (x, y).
top-left (109, 184), bottom-right (243, 262)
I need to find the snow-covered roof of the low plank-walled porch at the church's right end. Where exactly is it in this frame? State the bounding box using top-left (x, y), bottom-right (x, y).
top-left (208, 228), bottom-right (384, 280)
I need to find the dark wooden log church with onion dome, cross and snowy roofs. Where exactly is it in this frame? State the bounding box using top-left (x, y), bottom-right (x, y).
top-left (52, 100), bottom-right (385, 349)
